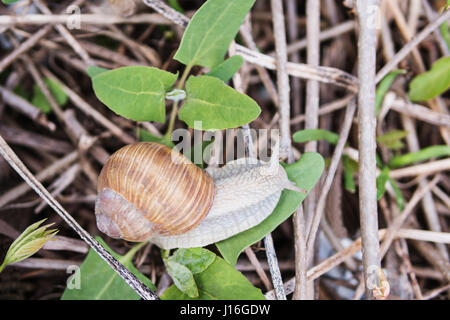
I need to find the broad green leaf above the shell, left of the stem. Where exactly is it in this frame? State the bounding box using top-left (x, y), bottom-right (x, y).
top-left (92, 66), bottom-right (177, 122)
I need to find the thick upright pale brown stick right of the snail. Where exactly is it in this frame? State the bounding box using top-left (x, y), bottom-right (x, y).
top-left (356, 0), bottom-right (381, 299)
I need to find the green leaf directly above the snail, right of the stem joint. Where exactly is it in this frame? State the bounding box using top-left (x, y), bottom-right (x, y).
top-left (178, 76), bottom-right (261, 131)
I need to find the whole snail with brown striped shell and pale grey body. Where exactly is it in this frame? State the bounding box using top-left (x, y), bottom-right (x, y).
top-left (95, 142), bottom-right (305, 249)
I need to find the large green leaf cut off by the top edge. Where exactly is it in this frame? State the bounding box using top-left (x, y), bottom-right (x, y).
top-left (174, 0), bottom-right (255, 69)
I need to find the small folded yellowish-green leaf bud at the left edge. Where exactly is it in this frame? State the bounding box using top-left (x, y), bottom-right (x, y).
top-left (0, 219), bottom-right (58, 272)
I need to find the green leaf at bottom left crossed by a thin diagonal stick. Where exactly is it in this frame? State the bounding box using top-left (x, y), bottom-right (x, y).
top-left (61, 237), bottom-right (155, 300)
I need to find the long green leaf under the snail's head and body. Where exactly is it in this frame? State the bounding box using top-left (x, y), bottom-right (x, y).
top-left (216, 152), bottom-right (324, 265)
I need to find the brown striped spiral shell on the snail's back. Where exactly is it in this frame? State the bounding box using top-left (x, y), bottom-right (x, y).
top-left (95, 142), bottom-right (214, 241)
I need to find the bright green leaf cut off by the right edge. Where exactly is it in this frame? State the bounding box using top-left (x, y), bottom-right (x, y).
top-left (408, 57), bottom-right (450, 101)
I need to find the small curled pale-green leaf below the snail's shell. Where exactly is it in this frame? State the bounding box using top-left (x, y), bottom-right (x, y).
top-left (165, 258), bottom-right (198, 298)
